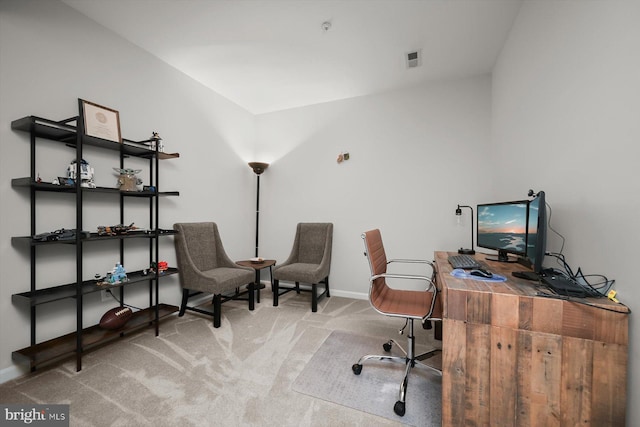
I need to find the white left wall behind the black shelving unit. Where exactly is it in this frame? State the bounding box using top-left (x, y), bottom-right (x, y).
top-left (0, 0), bottom-right (255, 379)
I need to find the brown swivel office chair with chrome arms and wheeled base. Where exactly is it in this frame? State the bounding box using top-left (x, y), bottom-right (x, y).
top-left (352, 229), bottom-right (442, 416)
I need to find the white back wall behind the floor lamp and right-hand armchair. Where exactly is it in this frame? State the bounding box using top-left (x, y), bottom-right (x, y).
top-left (257, 76), bottom-right (490, 298)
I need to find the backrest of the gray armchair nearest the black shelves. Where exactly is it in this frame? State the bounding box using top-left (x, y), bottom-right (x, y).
top-left (175, 222), bottom-right (221, 271)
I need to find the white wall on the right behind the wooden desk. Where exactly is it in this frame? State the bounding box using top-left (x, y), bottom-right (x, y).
top-left (492, 1), bottom-right (640, 425)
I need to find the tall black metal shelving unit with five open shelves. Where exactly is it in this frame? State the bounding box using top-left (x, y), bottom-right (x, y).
top-left (11, 100), bottom-right (180, 371)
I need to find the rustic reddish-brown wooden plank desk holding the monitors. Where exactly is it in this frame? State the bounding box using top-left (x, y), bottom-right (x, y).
top-left (435, 252), bottom-right (629, 427)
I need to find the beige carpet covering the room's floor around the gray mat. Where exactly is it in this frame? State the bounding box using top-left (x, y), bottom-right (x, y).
top-left (0, 291), bottom-right (439, 426)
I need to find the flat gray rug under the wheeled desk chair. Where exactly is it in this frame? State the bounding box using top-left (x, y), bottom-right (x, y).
top-left (292, 331), bottom-right (442, 427)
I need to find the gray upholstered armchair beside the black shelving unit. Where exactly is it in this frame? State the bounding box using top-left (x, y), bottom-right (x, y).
top-left (173, 222), bottom-right (255, 328)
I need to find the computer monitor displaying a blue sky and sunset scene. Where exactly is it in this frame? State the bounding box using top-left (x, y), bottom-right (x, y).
top-left (476, 200), bottom-right (529, 262)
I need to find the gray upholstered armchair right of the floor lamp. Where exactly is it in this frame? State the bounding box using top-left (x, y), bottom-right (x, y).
top-left (273, 223), bottom-right (333, 312)
